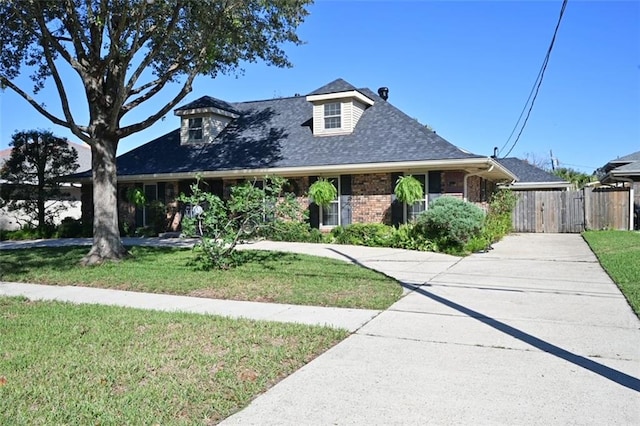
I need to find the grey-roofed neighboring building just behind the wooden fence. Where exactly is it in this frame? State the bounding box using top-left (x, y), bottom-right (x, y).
top-left (497, 157), bottom-right (572, 191)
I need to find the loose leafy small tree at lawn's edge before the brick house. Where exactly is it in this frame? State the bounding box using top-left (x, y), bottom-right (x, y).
top-left (179, 176), bottom-right (301, 269)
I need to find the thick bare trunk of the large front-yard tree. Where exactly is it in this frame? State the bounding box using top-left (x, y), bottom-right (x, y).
top-left (81, 137), bottom-right (128, 265)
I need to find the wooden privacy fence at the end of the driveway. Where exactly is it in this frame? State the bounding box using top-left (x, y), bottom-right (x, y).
top-left (513, 188), bottom-right (631, 233)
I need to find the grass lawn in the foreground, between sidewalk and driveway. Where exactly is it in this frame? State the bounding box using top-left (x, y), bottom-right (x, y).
top-left (0, 297), bottom-right (348, 425)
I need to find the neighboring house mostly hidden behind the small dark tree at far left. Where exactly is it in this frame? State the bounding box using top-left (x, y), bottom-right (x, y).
top-left (0, 140), bottom-right (91, 230)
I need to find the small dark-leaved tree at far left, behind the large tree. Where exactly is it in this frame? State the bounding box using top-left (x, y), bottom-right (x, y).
top-left (0, 130), bottom-right (79, 236)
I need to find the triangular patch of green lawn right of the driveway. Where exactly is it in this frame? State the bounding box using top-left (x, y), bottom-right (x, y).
top-left (583, 231), bottom-right (640, 318)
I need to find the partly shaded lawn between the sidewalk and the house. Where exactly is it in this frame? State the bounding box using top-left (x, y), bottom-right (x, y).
top-left (0, 247), bottom-right (402, 309)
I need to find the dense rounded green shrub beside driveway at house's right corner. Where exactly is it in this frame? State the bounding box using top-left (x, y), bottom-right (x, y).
top-left (415, 197), bottom-right (485, 253)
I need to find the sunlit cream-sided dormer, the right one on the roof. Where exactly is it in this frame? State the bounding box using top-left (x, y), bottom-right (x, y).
top-left (306, 79), bottom-right (373, 136)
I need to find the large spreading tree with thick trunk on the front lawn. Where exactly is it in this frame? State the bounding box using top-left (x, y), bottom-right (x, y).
top-left (0, 0), bottom-right (310, 264)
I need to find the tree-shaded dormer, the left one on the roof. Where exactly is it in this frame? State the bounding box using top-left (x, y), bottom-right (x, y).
top-left (174, 96), bottom-right (240, 145)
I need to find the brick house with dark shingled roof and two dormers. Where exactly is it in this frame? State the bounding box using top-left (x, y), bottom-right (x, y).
top-left (76, 79), bottom-right (517, 231)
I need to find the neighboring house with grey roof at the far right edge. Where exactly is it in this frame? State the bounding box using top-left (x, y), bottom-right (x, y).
top-left (597, 151), bottom-right (640, 229)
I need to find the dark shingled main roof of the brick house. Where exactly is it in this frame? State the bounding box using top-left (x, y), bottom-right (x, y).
top-left (94, 79), bottom-right (486, 176)
